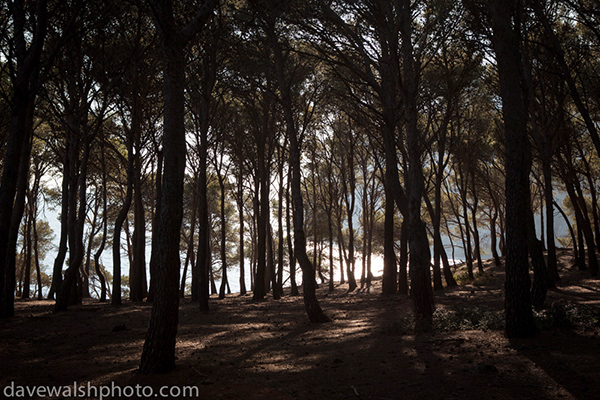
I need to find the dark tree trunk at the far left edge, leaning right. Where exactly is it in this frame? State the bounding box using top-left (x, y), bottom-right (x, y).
top-left (0, 0), bottom-right (48, 318)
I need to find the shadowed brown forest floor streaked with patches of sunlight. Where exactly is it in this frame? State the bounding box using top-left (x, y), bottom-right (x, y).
top-left (0, 250), bottom-right (600, 400)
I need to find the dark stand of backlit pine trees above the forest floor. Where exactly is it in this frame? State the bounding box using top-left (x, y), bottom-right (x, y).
top-left (0, 0), bottom-right (600, 373)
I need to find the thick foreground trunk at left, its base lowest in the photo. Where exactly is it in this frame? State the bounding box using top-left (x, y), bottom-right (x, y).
top-left (140, 32), bottom-right (186, 374)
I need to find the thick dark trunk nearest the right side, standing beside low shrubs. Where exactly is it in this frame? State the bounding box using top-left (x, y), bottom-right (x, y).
top-left (490, 0), bottom-right (537, 337)
